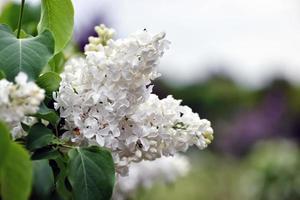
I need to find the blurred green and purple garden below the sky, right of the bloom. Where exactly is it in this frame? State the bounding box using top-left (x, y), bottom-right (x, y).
top-left (140, 75), bottom-right (300, 200)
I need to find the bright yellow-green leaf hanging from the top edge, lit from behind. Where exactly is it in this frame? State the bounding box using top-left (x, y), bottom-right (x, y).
top-left (38, 0), bottom-right (74, 54)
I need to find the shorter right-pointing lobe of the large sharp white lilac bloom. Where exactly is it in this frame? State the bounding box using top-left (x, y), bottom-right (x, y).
top-left (126, 94), bottom-right (213, 160)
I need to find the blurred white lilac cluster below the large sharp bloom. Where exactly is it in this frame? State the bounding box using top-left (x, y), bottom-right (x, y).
top-left (112, 154), bottom-right (190, 200)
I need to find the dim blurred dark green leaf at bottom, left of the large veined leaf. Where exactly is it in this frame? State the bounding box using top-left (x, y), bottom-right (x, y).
top-left (32, 160), bottom-right (54, 199)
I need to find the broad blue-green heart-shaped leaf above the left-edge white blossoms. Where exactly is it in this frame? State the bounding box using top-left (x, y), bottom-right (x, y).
top-left (0, 25), bottom-right (54, 81)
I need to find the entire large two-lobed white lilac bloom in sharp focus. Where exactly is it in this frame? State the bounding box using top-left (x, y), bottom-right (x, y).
top-left (54, 25), bottom-right (213, 174)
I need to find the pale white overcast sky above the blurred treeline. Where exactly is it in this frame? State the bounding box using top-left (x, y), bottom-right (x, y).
top-left (6, 0), bottom-right (300, 87)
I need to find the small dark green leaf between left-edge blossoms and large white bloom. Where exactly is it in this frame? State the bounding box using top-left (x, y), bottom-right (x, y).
top-left (32, 103), bottom-right (60, 126)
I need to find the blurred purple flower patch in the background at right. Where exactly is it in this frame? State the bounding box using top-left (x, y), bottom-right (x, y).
top-left (216, 90), bottom-right (288, 155)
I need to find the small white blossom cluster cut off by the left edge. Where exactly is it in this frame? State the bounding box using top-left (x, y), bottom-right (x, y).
top-left (0, 72), bottom-right (45, 138)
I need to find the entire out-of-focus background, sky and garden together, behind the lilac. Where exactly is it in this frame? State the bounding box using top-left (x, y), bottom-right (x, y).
top-left (0, 0), bottom-right (300, 200)
